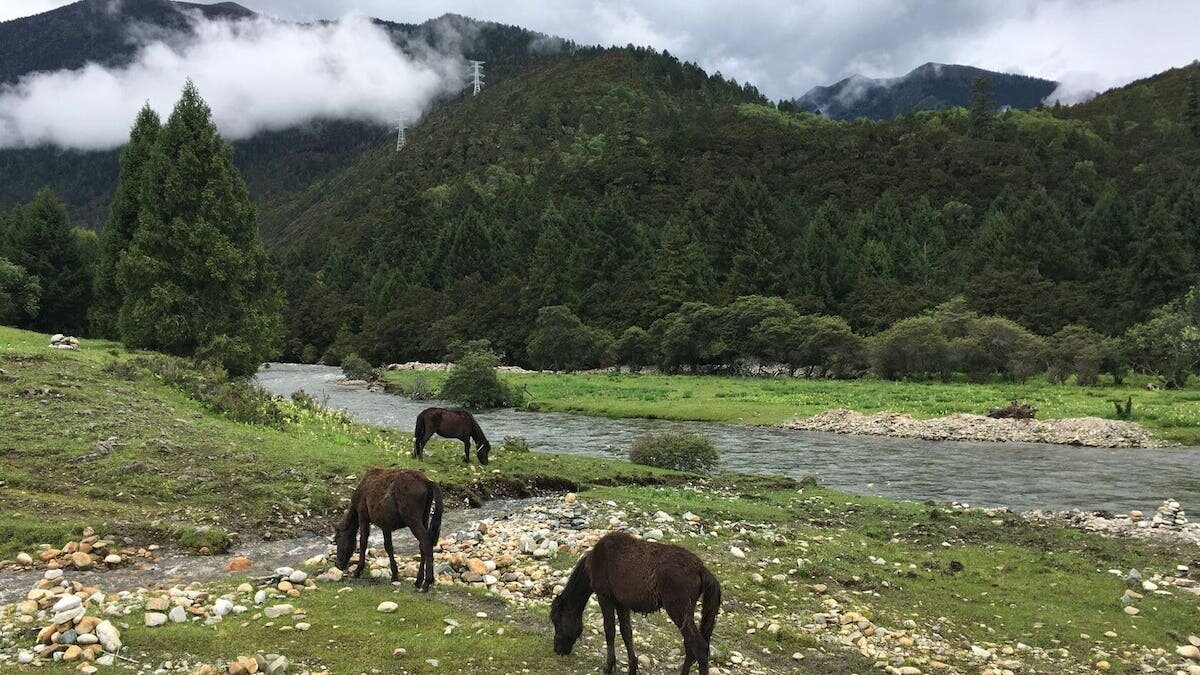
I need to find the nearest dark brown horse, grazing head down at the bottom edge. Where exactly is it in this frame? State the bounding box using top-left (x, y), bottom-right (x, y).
top-left (550, 532), bottom-right (721, 675)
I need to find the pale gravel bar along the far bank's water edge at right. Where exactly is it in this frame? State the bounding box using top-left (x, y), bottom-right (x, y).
top-left (784, 410), bottom-right (1163, 448)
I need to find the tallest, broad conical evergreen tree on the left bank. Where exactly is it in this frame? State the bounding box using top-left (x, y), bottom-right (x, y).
top-left (116, 82), bottom-right (281, 375)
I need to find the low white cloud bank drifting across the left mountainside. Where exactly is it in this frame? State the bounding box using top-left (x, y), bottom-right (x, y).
top-left (0, 12), bottom-right (464, 150)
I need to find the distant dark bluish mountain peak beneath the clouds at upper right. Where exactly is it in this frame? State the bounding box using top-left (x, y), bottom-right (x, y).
top-left (794, 62), bottom-right (1058, 120)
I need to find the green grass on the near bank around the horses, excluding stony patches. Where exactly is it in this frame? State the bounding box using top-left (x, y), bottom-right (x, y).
top-left (0, 329), bottom-right (1200, 674)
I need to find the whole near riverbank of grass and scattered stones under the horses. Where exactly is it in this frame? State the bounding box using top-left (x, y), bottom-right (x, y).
top-left (0, 329), bottom-right (1200, 675)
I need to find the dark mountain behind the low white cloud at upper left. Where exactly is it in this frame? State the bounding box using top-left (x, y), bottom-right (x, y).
top-left (0, 0), bottom-right (576, 228)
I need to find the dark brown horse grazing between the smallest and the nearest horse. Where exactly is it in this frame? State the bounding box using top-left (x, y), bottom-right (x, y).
top-left (334, 466), bottom-right (442, 591)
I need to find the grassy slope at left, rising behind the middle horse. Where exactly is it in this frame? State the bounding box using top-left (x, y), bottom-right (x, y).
top-left (0, 328), bottom-right (666, 555)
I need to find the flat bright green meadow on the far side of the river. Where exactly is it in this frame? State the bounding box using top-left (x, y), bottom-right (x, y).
top-left (385, 371), bottom-right (1200, 444)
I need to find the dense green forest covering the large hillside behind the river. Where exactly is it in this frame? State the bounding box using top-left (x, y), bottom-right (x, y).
top-left (266, 49), bottom-right (1200, 374)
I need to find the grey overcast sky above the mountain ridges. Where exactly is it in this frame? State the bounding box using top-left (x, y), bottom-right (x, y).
top-left (0, 0), bottom-right (1200, 98)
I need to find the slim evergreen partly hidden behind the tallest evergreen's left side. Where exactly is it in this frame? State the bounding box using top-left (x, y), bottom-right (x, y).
top-left (88, 103), bottom-right (161, 338)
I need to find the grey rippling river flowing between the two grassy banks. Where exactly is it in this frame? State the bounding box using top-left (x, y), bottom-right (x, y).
top-left (258, 364), bottom-right (1200, 512)
